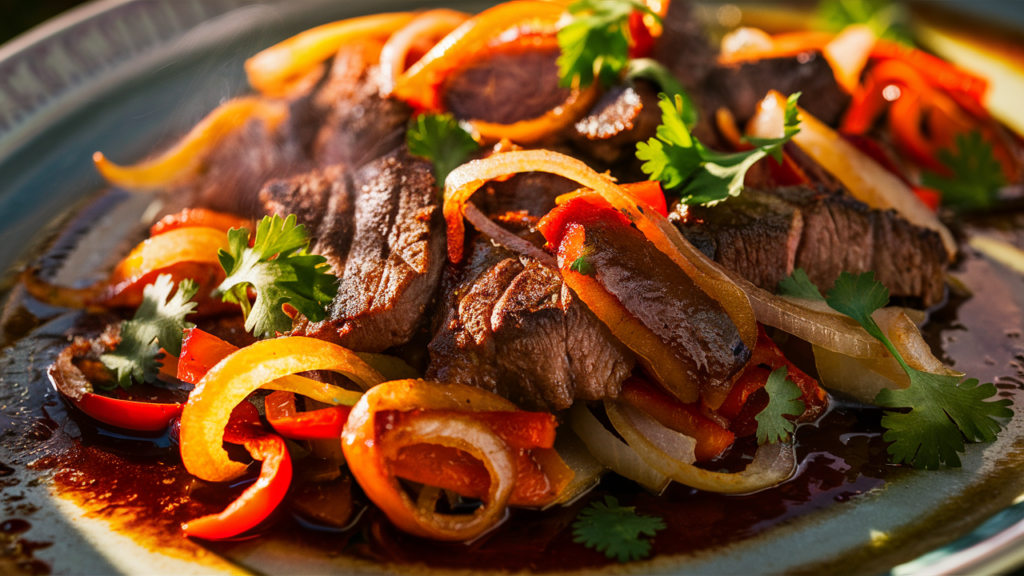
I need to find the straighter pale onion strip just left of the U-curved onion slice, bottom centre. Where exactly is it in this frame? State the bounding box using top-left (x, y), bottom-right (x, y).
top-left (569, 402), bottom-right (671, 494)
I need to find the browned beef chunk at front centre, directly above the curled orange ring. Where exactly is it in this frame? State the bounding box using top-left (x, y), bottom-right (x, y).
top-left (427, 238), bottom-right (634, 411)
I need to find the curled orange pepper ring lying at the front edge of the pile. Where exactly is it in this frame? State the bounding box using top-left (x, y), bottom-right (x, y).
top-left (342, 380), bottom-right (571, 540)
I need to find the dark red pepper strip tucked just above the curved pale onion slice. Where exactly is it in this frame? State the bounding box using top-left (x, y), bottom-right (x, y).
top-left (620, 377), bottom-right (735, 462)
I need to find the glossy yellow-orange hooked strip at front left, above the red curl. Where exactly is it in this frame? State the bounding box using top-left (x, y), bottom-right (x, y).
top-left (181, 336), bottom-right (384, 482)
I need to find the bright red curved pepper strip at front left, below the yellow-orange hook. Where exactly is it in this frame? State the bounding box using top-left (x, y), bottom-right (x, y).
top-left (181, 402), bottom-right (292, 540)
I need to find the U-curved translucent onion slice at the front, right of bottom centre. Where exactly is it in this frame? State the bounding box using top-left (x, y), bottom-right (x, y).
top-left (604, 400), bottom-right (797, 494)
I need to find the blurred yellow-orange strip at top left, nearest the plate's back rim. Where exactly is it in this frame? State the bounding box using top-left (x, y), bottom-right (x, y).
top-left (246, 12), bottom-right (415, 95)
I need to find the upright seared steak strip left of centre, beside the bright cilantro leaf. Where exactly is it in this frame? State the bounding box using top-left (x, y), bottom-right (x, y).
top-left (288, 147), bottom-right (444, 353)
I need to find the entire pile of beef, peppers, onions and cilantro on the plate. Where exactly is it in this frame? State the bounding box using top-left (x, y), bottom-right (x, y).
top-left (9, 0), bottom-right (1022, 562)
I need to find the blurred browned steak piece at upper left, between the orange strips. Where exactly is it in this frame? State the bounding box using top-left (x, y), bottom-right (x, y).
top-left (308, 42), bottom-right (412, 166)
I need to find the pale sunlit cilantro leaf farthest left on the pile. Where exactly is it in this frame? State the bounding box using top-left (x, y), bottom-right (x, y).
top-left (99, 274), bottom-right (199, 388)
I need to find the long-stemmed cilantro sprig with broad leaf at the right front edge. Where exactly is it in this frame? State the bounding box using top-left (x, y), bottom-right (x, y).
top-left (825, 272), bottom-right (1014, 469)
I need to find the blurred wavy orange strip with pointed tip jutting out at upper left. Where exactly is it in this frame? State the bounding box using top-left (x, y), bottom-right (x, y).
top-left (92, 96), bottom-right (289, 192)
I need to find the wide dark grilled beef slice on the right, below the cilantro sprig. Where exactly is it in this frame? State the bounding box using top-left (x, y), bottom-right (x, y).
top-left (671, 187), bottom-right (948, 306)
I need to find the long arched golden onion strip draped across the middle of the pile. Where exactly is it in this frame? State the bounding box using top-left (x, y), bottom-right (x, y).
top-left (444, 150), bottom-right (757, 349)
